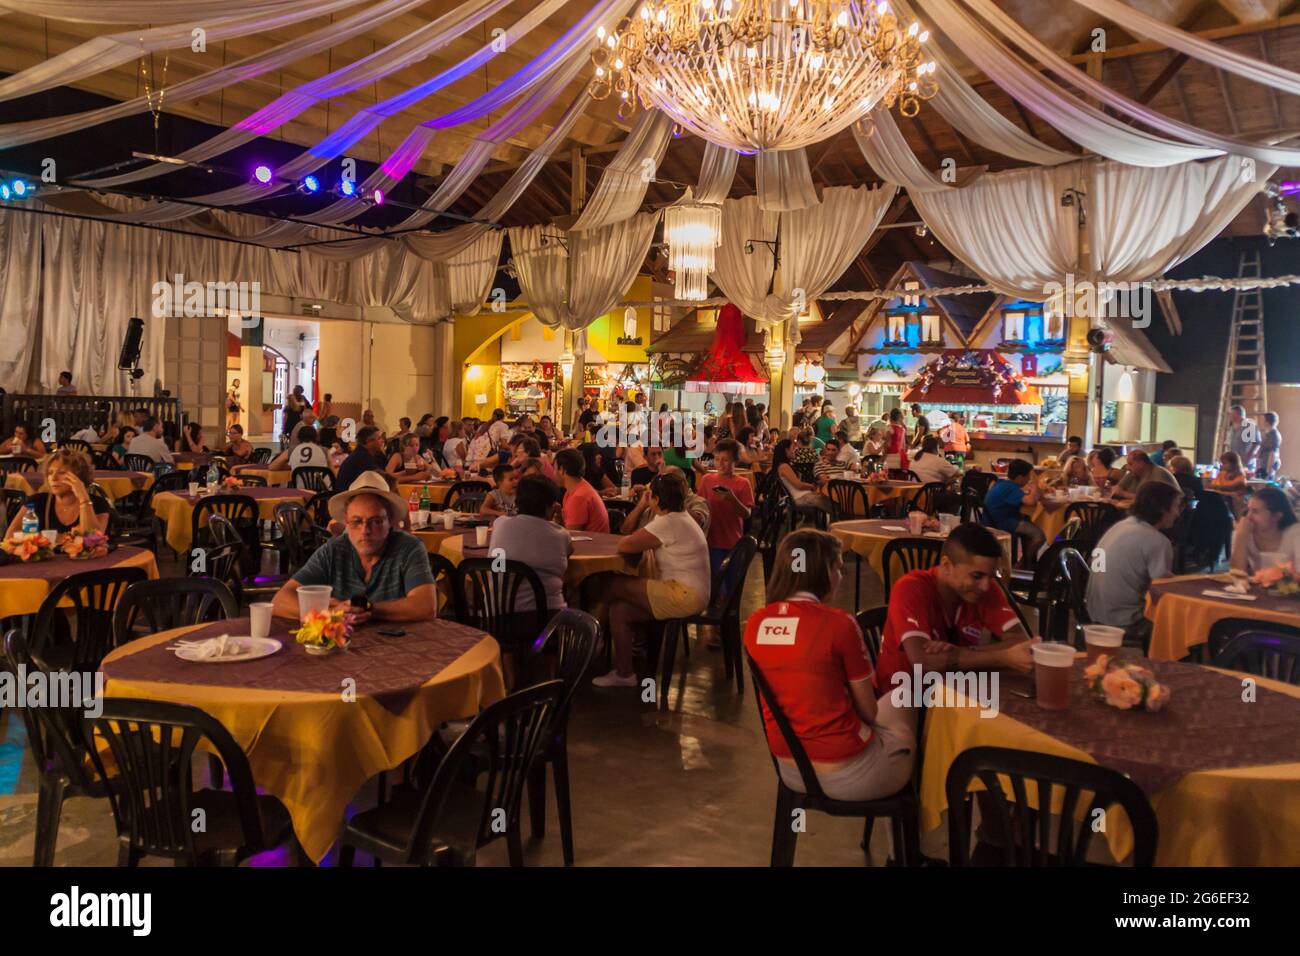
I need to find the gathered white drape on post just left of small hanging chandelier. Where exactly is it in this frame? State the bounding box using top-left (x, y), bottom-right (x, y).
top-left (508, 212), bottom-right (659, 332)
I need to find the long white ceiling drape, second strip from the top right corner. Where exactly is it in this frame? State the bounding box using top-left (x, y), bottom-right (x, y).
top-left (966, 0), bottom-right (1300, 165)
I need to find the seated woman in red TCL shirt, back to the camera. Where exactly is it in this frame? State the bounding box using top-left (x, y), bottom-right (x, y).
top-left (745, 531), bottom-right (917, 800)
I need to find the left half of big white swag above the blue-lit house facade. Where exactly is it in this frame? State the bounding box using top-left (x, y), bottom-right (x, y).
top-left (909, 164), bottom-right (1092, 302)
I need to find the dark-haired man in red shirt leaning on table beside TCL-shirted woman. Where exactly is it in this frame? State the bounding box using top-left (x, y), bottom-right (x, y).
top-left (876, 524), bottom-right (1032, 695)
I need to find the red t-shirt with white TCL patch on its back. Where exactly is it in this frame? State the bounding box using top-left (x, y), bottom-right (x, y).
top-left (745, 600), bottom-right (871, 762)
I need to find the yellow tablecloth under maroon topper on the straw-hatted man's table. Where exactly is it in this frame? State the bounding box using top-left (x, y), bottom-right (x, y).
top-left (104, 627), bottom-right (506, 861)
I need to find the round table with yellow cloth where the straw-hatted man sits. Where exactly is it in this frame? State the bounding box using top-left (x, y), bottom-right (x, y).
top-left (101, 618), bottom-right (506, 861)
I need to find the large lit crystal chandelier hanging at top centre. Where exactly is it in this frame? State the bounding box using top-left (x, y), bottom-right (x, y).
top-left (590, 0), bottom-right (939, 152)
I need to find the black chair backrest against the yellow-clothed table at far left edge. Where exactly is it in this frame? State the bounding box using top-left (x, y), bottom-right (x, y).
top-left (31, 567), bottom-right (148, 672)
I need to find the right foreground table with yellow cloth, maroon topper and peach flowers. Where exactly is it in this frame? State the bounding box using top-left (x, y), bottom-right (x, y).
top-left (920, 654), bottom-right (1300, 866)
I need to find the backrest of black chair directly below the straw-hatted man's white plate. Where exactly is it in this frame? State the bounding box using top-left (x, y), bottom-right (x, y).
top-left (86, 697), bottom-right (265, 860)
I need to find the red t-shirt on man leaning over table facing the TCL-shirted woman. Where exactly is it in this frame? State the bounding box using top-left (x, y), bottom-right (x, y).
top-left (876, 567), bottom-right (1021, 695)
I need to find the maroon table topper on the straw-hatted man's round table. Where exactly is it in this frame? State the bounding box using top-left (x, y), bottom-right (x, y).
top-left (100, 618), bottom-right (485, 714)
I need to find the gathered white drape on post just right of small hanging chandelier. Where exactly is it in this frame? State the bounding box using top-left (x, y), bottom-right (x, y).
top-left (712, 186), bottom-right (897, 328)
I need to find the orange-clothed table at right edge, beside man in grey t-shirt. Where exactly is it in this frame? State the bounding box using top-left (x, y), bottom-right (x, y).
top-left (1145, 575), bottom-right (1300, 661)
